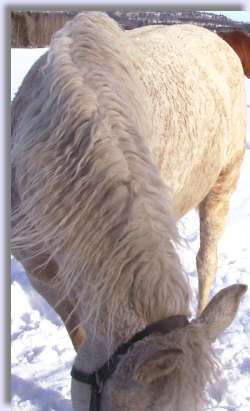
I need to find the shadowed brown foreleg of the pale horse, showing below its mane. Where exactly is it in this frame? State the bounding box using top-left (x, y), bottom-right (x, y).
top-left (13, 250), bottom-right (85, 351)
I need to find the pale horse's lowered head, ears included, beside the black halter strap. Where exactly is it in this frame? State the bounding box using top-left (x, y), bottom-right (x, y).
top-left (72, 285), bottom-right (247, 411)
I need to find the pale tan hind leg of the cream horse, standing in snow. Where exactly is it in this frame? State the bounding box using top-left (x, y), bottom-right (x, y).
top-left (196, 153), bottom-right (243, 313)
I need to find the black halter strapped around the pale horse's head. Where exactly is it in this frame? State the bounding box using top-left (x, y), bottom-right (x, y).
top-left (71, 315), bottom-right (189, 411)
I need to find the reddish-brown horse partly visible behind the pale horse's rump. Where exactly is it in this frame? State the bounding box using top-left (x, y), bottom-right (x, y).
top-left (217, 30), bottom-right (250, 78)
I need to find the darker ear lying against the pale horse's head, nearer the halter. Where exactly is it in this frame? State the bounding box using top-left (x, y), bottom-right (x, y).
top-left (134, 348), bottom-right (183, 384)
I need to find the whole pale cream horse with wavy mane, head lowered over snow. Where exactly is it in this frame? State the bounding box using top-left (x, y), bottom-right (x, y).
top-left (11, 12), bottom-right (247, 411)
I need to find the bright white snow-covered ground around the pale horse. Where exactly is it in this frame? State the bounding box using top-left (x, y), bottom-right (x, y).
top-left (11, 49), bottom-right (250, 411)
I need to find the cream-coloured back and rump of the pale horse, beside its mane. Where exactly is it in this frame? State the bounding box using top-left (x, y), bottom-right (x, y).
top-left (129, 25), bottom-right (245, 215)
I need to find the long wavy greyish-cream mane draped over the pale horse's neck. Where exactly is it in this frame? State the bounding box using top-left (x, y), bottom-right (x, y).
top-left (12, 13), bottom-right (187, 334)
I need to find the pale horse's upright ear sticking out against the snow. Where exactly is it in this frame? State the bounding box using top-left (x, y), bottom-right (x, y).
top-left (198, 284), bottom-right (247, 342)
